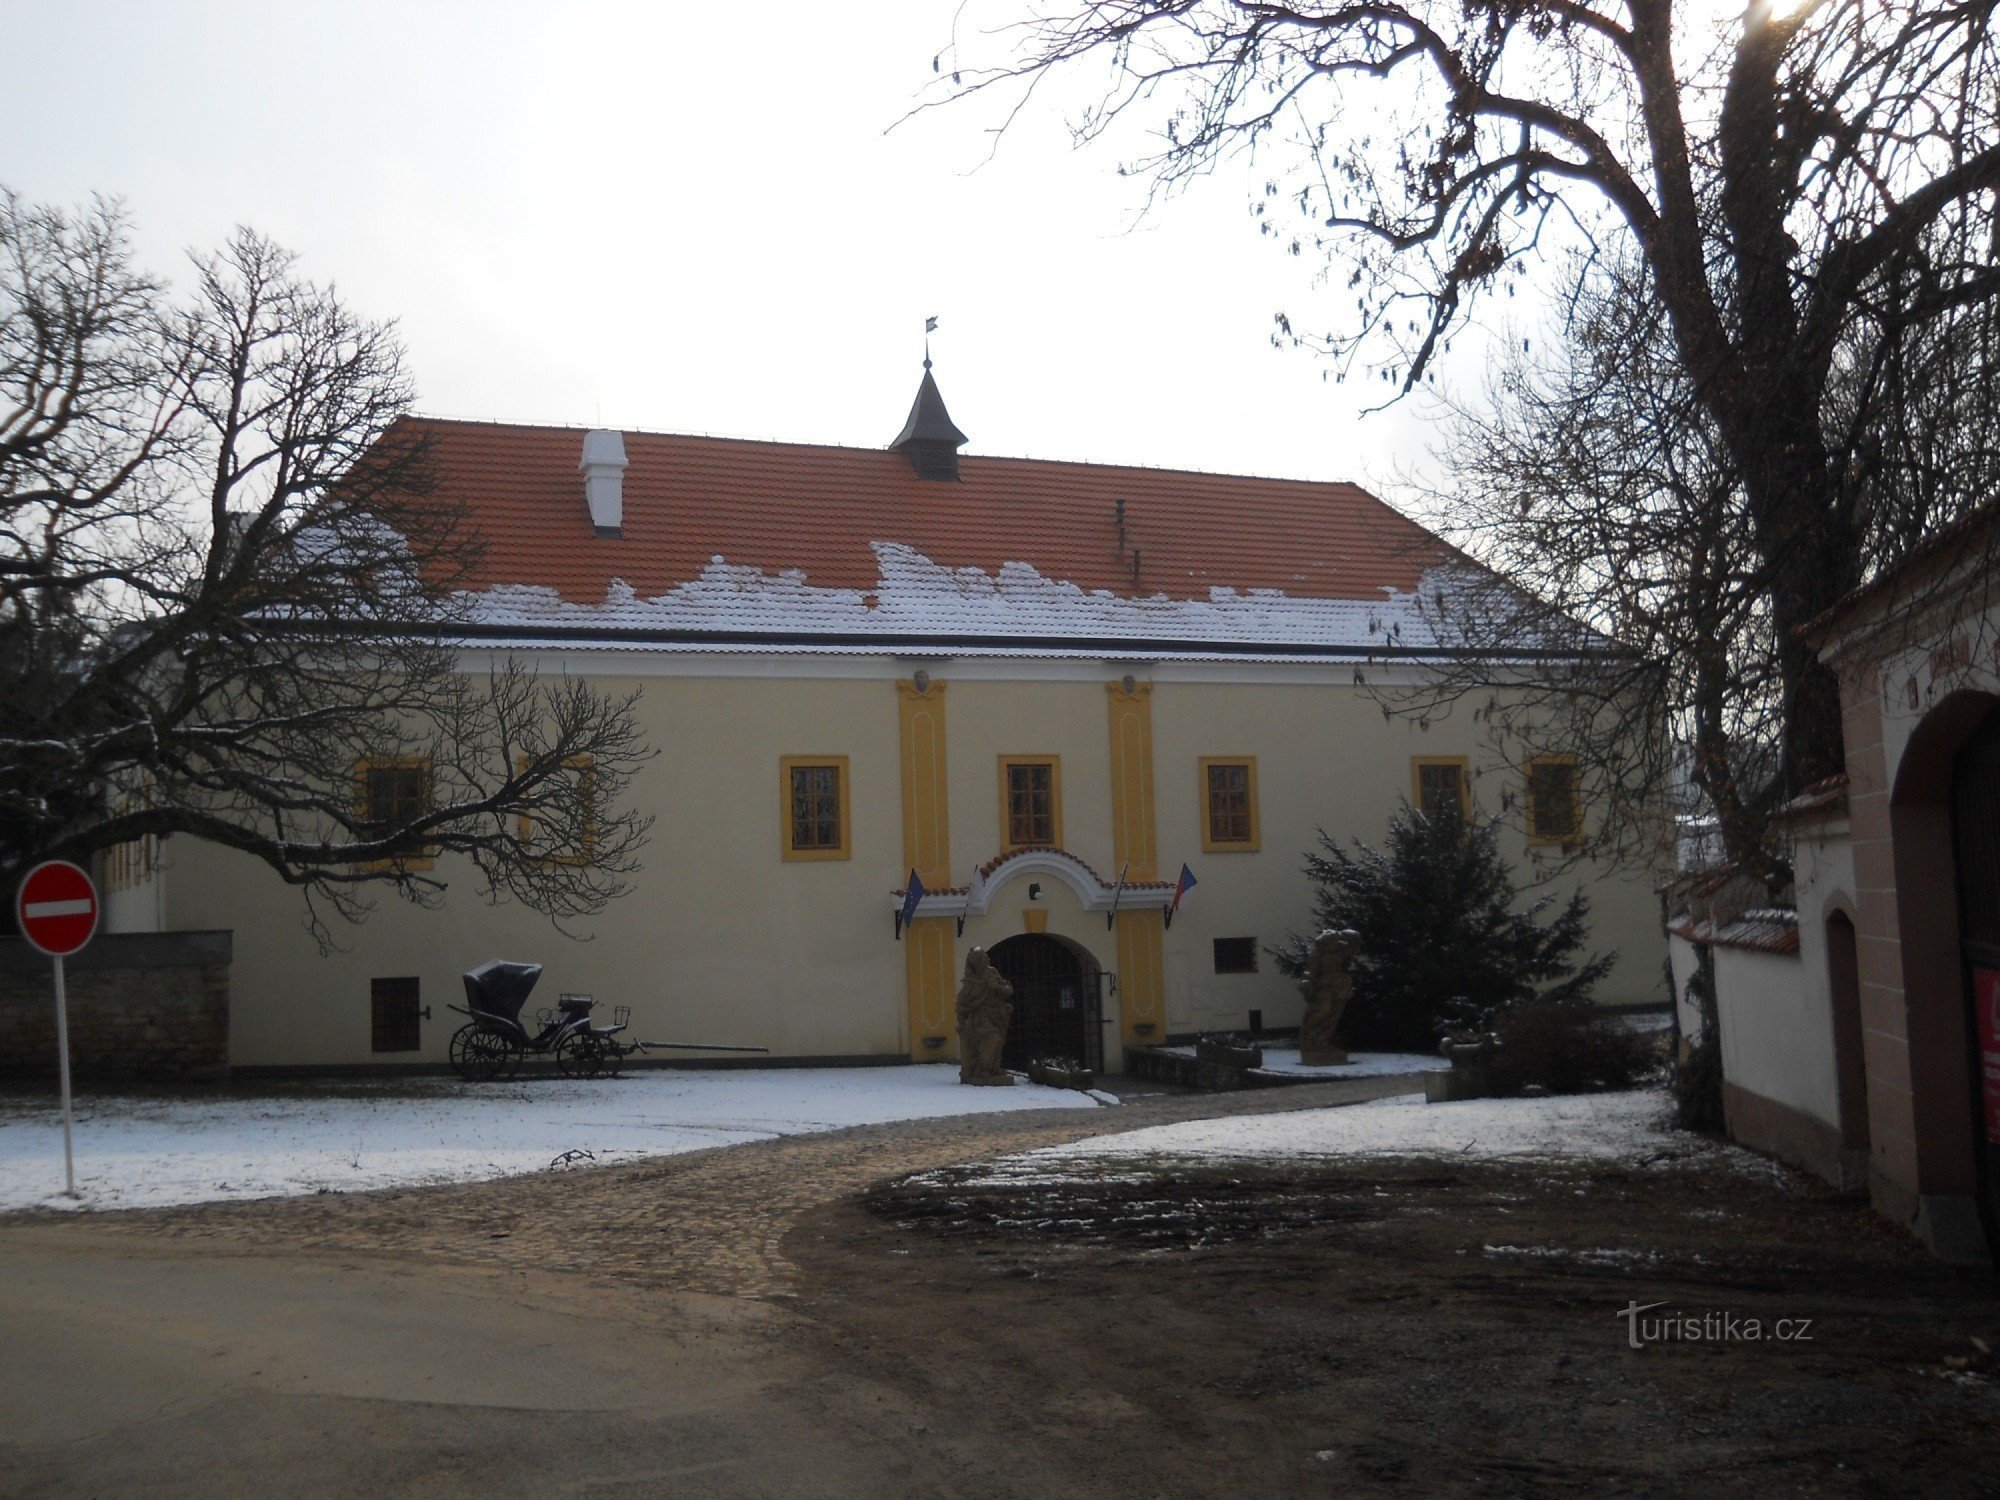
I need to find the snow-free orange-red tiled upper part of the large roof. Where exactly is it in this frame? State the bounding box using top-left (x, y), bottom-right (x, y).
top-left (406, 418), bottom-right (1462, 606)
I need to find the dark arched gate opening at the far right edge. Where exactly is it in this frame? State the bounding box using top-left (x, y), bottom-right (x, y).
top-left (1952, 708), bottom-right (2000, 1250)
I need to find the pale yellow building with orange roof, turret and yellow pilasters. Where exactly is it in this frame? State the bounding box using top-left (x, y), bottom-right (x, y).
top-left (108, 362), bottom-right (1664, 1070)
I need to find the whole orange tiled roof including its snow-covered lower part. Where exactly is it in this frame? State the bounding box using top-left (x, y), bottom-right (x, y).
top-left (382, 418), bottom-right (1600, 656)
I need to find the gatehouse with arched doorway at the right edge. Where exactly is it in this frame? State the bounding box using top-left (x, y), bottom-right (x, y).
top-left (1798, 508), bottom-right (2000, 1262)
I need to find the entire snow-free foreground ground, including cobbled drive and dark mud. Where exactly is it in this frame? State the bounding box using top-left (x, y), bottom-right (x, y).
top-left (0, 1084), bottom-right (2000, 1496)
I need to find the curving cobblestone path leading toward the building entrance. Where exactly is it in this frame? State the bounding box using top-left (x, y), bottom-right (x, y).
top-left (35, 1076), bottom-right (1418, 1298)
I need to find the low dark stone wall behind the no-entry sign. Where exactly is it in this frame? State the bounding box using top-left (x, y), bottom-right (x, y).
top-left (0, 932), bottom-right (232, 1082)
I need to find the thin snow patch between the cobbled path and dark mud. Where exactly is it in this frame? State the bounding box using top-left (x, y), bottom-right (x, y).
top-left (944, 1090), bottom-right (1728, 1186)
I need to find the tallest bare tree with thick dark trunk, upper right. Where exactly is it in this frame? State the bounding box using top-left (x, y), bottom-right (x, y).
top-left (954, 0), bottom-right (2000, 788)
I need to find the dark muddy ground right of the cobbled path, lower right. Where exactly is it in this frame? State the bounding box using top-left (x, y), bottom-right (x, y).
top-left (786, 1158), bottom-right (2000, 1496)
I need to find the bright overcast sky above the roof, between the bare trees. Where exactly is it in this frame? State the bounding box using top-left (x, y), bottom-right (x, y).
top-left (0, 0), bottom-right (1472, 502)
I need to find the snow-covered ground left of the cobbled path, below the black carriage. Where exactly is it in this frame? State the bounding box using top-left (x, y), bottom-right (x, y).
top-left (0, 1064), bottom-right (1116, 1210)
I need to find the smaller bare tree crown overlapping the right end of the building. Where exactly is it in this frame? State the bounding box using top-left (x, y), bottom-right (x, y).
top-left (1408, 270), bottom-right (1782, 880)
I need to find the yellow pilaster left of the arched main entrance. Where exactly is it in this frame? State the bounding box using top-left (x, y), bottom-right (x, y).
top-left (896, 682), bottom-right (958, 1062)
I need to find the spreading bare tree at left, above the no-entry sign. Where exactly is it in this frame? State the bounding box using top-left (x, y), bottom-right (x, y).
top-left (0, 194), bottom-right (650, 942)
